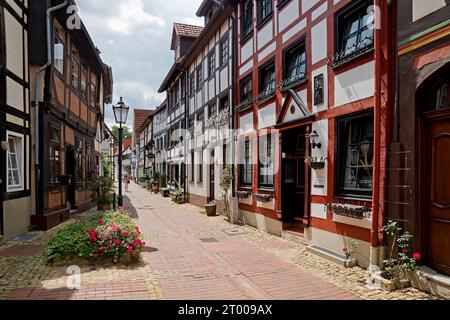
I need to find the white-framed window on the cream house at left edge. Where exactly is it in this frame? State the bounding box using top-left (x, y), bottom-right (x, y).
top-left (6, 133), bottom-right (24, 192)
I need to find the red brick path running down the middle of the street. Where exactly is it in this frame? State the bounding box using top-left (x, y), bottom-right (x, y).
top-left (9, 184), bottom-right (356, 300)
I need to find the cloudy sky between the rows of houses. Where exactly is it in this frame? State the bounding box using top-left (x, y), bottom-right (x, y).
top-left (76, 0), bottom-right (203, 125)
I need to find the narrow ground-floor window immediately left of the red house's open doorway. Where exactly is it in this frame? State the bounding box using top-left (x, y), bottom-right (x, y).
top-left (259, 134), bottom-right (275, 188)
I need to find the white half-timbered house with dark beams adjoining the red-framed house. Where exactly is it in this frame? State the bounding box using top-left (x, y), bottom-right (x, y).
top-left (181, 0), bottom-right (234, 211)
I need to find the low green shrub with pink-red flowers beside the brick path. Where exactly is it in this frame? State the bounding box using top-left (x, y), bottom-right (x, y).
top-left (44, 208), bottom-right (145, 262)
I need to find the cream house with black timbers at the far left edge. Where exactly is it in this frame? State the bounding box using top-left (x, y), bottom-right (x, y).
top-left (0, 0), bottom-right (34, 241)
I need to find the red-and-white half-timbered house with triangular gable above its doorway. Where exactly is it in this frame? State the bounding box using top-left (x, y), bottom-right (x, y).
top-left (236, 0), bottom-right (392, 266)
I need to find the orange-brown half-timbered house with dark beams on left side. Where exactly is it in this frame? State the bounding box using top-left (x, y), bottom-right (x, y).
top-left (29, 0), bottom-right (112, 229)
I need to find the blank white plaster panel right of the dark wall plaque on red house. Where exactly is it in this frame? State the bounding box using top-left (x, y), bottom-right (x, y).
top-left (334, 61), bottom-right (375, 107)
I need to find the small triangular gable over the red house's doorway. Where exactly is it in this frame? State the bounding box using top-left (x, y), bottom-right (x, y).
top-left (275, 89), bottom-right (314, 128)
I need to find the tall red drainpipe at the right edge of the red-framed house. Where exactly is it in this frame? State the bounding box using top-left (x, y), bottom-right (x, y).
top-left (370, 0), bottom-right (383, 266)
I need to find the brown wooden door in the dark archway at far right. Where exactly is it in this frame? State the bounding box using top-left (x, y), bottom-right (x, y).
top-left (425, 112), bottom-right (450, 275)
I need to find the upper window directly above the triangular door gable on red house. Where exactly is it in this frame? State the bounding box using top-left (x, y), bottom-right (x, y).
top-left (284, 40), bottom-right (306, 85)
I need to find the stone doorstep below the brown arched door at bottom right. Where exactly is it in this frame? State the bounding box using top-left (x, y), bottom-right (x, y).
top-left (411, 266), bottom-right (450, 299)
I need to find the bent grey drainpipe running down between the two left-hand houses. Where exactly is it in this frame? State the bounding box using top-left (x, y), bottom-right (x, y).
top-left (34, 0), bottom-right (68, 215)
